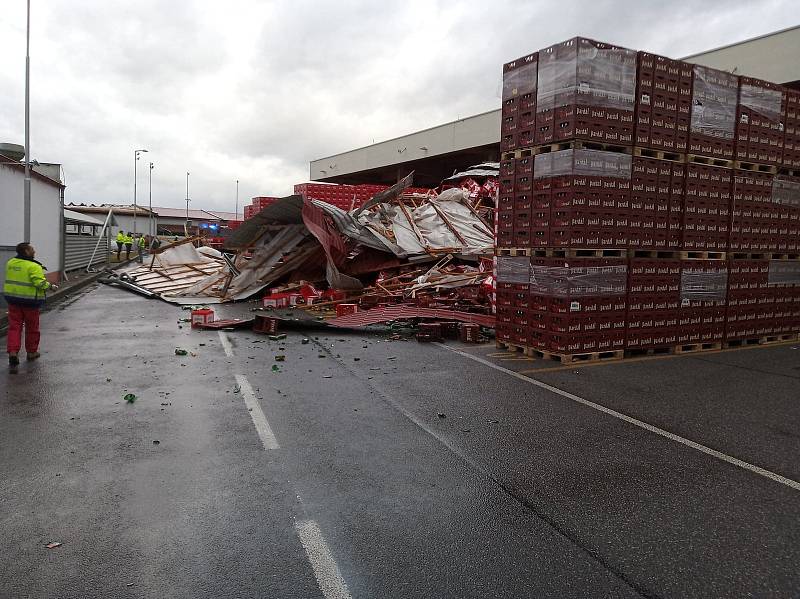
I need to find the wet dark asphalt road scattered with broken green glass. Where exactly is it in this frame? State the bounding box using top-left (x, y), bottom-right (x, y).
top-left (0, 287), bottom-right (800, 598)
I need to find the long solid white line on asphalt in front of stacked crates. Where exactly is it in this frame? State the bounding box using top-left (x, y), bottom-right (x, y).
top-left (436, 343), bottom-right (800, 491)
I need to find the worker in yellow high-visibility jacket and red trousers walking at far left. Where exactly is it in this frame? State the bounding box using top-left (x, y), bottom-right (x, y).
top-left (3, 242), bottom-right (58, 372)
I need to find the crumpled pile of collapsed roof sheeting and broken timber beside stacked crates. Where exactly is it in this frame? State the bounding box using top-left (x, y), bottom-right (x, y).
top-left (106, 171), bottom-right (496, 318)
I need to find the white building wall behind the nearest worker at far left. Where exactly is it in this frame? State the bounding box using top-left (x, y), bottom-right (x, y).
top-left (0, 165), bottom-right (61, 281)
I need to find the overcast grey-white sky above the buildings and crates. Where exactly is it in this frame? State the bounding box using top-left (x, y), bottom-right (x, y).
top-left (0, 0), bottom-right (800, 211)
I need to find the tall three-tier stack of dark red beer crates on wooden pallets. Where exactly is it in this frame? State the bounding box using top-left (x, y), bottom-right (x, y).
top-left (496, 38), bottom-right (800, 361)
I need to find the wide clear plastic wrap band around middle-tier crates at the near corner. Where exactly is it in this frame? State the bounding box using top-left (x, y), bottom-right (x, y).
top-left (533, 149), bottom-right (633, 179)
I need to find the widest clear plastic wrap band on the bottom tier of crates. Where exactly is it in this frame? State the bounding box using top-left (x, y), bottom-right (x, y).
top-left (530, 264), bottom-right (628, 298)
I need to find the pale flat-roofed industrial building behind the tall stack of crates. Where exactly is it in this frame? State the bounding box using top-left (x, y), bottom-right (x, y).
top-left (309, 25), bottom-right (800, 186)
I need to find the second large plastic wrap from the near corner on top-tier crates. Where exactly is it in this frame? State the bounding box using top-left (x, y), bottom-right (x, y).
top-left (691, 65), bottom-right (738, 139)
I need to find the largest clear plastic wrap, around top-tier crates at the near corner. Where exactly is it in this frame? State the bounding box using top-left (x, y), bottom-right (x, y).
top-left (536, 38), bottom-right (636, 112)
